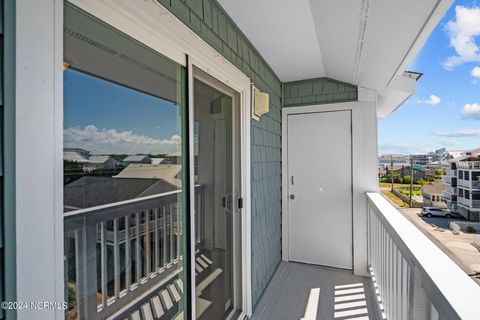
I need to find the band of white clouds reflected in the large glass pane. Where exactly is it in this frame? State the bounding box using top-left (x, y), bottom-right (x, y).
top-left (63, 124), bottom-right (181, 154)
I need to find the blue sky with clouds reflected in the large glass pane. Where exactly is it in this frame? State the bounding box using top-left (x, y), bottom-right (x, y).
top-left (64, 69), bottom-right (181, 154)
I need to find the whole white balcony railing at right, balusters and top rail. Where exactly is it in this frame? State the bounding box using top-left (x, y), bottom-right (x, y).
top-left (367, 193), bottom-right (480, 320)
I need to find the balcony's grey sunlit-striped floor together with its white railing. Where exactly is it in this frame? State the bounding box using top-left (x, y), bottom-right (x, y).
top-left (248, 193), bottom-right (480, 320)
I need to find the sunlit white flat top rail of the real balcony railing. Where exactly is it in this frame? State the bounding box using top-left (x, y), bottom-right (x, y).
top-left (367, 193), bottom-right (480, 319)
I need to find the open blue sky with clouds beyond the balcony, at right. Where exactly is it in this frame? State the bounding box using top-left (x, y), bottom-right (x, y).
top-left (379, 1), bottom-right (480, 154)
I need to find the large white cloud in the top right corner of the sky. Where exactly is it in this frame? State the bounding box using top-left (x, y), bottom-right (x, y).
top-left (443, 6), bottom-right (480, 69)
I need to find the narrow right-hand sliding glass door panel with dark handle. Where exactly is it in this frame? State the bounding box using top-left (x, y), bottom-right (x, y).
top-left (193, 70), bottom-right (240, 320)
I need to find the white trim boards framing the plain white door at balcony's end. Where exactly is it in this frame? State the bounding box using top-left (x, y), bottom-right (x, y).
top-left (282, 101), bottom-right (378, 276)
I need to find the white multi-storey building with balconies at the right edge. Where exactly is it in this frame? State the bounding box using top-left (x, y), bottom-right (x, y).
top-left (442, 149), bottom-right (480, 221)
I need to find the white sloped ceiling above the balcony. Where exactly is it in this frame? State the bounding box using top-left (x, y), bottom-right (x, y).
top-left (219, 0), bottom-right (451, 91)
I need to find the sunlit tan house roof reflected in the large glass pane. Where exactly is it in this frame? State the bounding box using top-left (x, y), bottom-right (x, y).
top-left (115, 163), bottom-right (182, 187)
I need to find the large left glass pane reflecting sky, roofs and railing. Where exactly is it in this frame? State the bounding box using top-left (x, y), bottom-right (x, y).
top-left (63, 5), bottom-right (187, 319)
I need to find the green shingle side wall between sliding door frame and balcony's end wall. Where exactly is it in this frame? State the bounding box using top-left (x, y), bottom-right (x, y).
top-left (158, 0), bottom-right (282, 304)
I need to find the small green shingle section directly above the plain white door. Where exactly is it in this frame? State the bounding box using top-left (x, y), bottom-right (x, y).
top-left (283, 78), bottom-right (358, 107)
